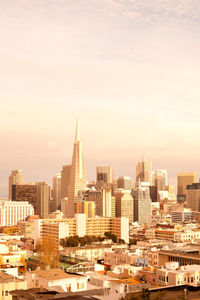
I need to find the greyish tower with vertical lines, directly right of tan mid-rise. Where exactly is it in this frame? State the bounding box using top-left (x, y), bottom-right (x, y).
top-left (133, 184), bottom-right (151, 224)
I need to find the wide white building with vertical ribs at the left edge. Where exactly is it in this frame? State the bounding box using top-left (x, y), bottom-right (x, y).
top-left (0, 201), bottom-right (34, 226)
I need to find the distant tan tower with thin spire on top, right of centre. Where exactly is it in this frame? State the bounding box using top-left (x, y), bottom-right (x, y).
top-left (136, 157), bottom-right (152, 185)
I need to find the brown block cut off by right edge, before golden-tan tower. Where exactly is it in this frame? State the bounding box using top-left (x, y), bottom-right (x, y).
top-left (186, 183), bottom-right (200, 212)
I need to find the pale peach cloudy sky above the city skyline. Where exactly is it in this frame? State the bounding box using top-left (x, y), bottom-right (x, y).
top-left (0, 0), bottom-right (200, 196)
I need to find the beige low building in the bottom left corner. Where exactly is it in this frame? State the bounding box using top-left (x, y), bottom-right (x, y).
top-left (0, 271), bottom-right (27, 300)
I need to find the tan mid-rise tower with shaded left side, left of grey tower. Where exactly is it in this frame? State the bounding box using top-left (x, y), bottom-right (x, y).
top-left (114, 190), bottom-right (133, 222)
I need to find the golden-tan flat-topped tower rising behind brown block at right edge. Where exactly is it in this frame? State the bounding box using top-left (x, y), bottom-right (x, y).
top-left (177, 172), bottom-right (196, 202)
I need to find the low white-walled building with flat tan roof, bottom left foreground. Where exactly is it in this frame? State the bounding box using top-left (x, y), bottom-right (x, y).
top-left (26, 269), bottom-right (87, 293)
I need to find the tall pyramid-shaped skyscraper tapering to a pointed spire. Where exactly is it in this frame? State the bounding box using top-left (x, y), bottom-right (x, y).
top-left (66, 121), bottom-right (86, 218)
